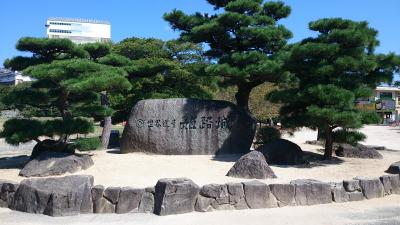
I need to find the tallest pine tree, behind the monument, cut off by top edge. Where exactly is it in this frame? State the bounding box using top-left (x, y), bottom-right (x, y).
top-left (164, 0), bottom-right (292, 113)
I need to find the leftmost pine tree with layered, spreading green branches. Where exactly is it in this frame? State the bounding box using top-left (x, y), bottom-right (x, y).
top-left (1, 37), bottom-right (131, 154)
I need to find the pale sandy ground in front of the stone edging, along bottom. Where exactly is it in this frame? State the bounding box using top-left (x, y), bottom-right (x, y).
top-left (0, 195), bottom-right (400, 225)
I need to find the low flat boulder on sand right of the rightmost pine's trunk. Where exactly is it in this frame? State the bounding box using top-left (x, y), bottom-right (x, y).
top-left (335, 144), bottom-right (382, 159)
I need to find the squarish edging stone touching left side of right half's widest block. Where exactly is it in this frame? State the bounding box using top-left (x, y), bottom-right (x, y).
top-left (269, 184), bottom-right (295, 207)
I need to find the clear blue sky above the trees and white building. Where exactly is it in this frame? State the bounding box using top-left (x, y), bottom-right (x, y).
top-left (0, 0), bottom-right (400, 65)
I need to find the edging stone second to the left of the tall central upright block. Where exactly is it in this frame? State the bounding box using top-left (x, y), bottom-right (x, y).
top-left (115, 187), bottom-right (144, 214)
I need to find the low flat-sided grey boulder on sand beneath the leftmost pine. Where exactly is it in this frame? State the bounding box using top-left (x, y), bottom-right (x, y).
top-left (19, 152), bottom-right (93, 177)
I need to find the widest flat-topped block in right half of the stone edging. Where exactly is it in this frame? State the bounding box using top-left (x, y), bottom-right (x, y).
top-left (290, 180), bottom-right (332, 205)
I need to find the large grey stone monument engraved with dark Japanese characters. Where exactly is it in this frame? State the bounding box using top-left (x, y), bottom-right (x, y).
top-left (121, 98), bottom-right (256, 155)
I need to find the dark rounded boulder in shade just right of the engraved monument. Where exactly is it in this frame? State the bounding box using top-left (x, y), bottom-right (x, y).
top-left (257, 139), bottom-right (304, 165)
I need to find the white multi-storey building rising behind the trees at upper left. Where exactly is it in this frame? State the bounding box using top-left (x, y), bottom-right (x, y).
top-left (46, 17), bottom-right (111, 44)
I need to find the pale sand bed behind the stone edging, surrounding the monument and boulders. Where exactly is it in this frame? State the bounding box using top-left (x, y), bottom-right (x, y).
top-left (0, 126), bottom-right (400, 187)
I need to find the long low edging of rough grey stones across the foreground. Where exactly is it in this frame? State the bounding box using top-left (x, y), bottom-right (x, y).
top-left (0, 174), bottom-right (400, 216)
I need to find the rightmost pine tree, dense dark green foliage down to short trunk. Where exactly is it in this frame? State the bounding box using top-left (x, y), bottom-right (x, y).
top-left (269, 18), bottom-right (399, 159)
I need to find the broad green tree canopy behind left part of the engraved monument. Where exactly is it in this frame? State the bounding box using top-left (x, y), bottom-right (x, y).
top-left (111, 38), bottom-right (215, 121)
